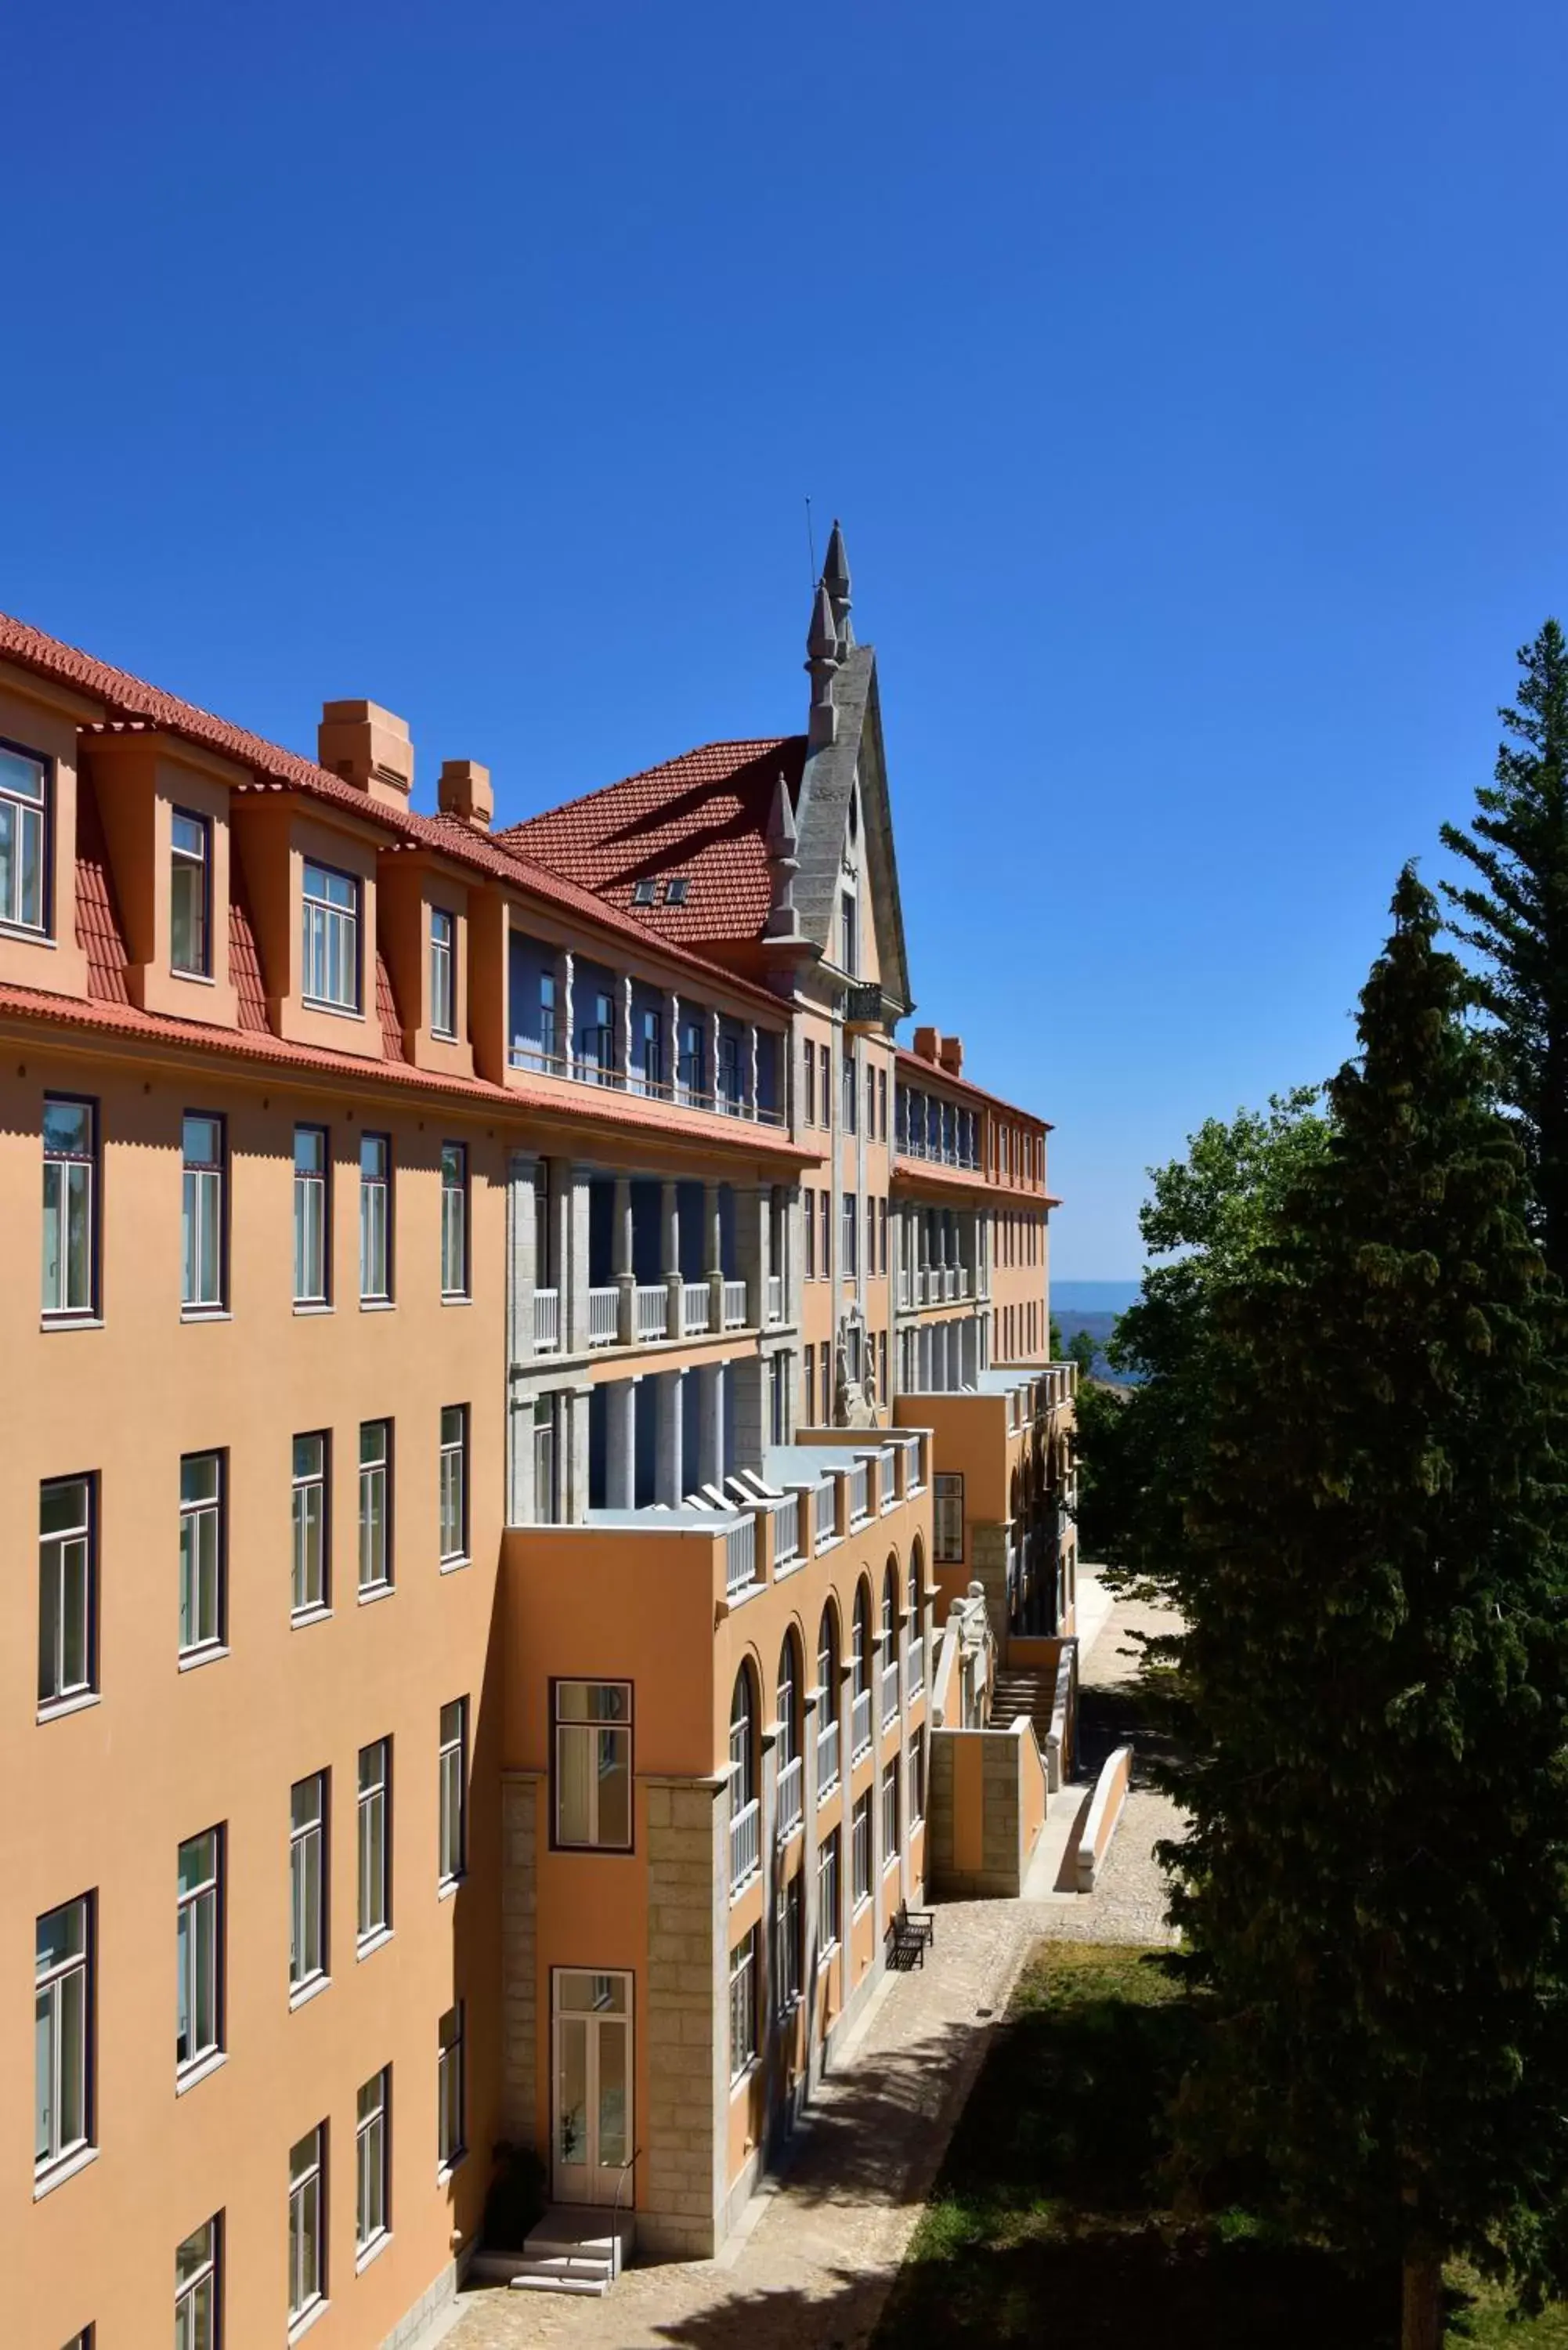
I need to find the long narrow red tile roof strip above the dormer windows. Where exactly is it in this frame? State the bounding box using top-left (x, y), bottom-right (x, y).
top-left (0, 613), bottom-right (799, 1010)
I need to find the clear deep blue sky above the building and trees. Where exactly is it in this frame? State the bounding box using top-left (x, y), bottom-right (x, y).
top-left (0, 0), bottom-right (1568, 1276)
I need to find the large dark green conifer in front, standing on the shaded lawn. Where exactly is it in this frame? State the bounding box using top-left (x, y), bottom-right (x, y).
top-left (1166, 872), bottom-right (1568, 2350)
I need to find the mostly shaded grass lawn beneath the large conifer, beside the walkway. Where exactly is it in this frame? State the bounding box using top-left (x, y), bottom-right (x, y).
top-left (875, 1943), bottom-right (1568, 2350)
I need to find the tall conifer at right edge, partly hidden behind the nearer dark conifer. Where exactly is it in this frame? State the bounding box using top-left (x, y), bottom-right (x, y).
top-left (1443, 620), bottom-right (1568, 1283)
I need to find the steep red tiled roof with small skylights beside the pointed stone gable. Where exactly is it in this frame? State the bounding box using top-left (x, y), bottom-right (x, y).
top-left (496, 736), bottom-right (807, 945)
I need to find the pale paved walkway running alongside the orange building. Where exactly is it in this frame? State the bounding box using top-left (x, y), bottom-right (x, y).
top-left (444, 1605), bottom-right (1178, 2350)
